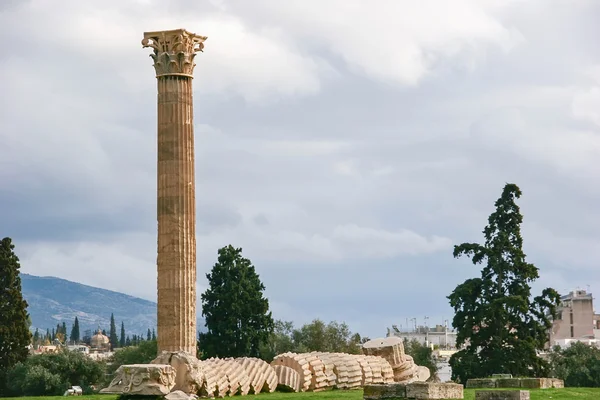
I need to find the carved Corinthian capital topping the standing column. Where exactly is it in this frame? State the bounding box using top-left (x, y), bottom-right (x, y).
top-left (142, 29), bottom-right (207, 78)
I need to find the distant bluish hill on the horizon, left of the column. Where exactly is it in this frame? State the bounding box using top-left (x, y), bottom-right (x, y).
top-left (21, 274), bottom-right (205, 336)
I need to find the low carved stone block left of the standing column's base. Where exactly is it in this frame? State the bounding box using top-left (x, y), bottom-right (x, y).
top-left (100, 364), bottom-right (175, 396)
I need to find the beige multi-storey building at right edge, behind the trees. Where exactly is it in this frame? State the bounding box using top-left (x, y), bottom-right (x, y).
top-left (550, 289), bottom-right (600, 347)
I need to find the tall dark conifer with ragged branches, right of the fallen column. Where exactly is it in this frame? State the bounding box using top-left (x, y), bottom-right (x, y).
top-left (448, 184), bottom-right (560, 383)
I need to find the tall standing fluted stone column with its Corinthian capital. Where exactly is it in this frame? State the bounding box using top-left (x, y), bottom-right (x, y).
top-left (142, 29), bottom-right (206, 357)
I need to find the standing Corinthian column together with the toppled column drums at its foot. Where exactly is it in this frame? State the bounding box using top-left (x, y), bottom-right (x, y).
top-left (101, 29), bottom-right (436, 399)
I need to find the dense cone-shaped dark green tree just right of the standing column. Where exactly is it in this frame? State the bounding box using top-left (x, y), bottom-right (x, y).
top-left (200, 245), bottom-right (274, 357)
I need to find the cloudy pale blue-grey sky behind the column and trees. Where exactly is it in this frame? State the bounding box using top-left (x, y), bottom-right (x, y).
top-left (0, 0), bottom-right (600, 337)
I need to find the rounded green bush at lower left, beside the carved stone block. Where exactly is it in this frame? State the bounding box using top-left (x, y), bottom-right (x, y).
top-left (7, 350), bottom-right (105, 396)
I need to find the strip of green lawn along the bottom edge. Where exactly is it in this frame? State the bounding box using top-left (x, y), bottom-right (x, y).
top-left (7, 388), bottom-right (600, 400)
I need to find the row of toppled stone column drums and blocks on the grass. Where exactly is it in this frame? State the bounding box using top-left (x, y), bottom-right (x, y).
top-left (102, 338), bottom-right (432, 397)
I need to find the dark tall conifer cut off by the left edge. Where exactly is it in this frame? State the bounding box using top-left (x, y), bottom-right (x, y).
top-left (0, 237), bottom-right (31, 395)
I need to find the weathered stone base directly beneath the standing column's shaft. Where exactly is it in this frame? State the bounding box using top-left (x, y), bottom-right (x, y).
top-left (152, 351), bottom-right (204, 394)
